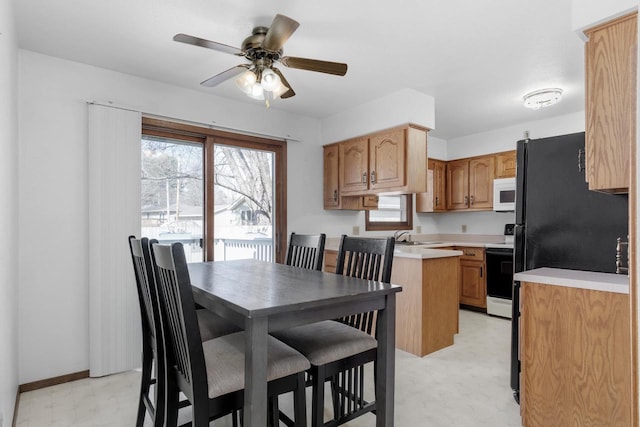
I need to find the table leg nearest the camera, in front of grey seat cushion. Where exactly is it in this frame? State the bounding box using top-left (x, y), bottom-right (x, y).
top-left (244, 317), bottom-right (268, 427)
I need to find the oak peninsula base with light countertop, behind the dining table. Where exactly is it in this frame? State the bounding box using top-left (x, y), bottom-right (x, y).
top-left (325, 246), bottom-right (462, 356)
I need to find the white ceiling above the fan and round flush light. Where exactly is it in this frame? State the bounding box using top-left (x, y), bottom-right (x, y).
top-left (14, 0), bottom-right (584, 139)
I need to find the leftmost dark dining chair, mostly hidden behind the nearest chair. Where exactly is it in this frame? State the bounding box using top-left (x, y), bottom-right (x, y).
top-left (129, 236), bottom-right (240, 427)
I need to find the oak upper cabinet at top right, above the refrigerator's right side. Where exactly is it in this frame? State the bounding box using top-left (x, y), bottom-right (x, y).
top-left (585, 13), bottom-right (638, 193)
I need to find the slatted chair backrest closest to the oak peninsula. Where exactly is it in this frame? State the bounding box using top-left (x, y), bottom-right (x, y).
top-left (336, 235), bottom-right (395, 335)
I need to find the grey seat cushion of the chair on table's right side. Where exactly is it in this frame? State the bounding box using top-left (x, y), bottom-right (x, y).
top-left (273, 320), bottom-right (378, 366)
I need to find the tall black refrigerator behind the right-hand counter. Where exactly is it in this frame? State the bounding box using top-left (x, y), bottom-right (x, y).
top-left (511, 132), bottom-right (628, 401)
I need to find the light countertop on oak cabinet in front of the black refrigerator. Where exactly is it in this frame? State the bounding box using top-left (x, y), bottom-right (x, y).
top-left (513, 267), bottom-right (629, 294)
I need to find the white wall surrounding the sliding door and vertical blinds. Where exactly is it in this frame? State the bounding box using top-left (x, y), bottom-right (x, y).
top-left (16, 51), bottom-right (322, 383)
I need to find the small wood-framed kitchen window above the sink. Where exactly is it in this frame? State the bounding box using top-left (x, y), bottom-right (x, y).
top-left (365, 194), bottom-right (413, 231)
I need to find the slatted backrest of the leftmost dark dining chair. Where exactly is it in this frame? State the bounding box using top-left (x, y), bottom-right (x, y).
top-left (129, 236), bottom-right (162, 345)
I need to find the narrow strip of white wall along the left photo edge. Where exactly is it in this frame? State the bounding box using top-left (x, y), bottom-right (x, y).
top-left (0, 0), bottom-right (20, 426)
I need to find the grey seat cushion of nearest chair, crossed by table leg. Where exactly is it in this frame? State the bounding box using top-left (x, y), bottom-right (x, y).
top-left (202, 332), bottom-right (311, 399)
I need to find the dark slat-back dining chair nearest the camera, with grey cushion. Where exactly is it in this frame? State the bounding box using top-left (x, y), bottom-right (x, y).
top-left (152, 243), bottom-right (310, 427)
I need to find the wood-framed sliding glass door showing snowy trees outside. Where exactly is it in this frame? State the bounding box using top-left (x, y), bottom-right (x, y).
top-left (141, 118), bottom-right (286, 262)
